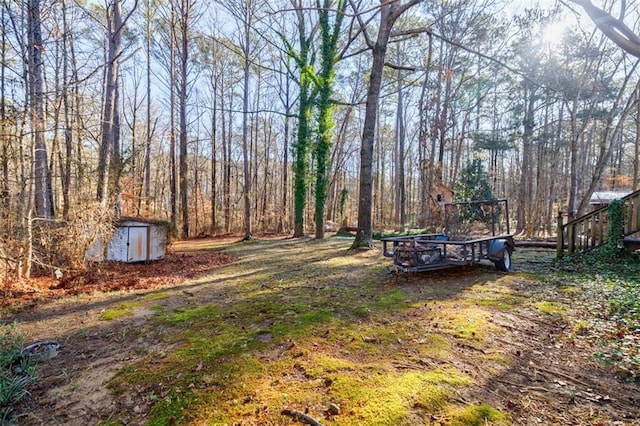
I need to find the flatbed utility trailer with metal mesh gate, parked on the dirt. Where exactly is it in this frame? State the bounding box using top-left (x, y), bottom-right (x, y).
top-left (381, 200), bottom-right (515, 278)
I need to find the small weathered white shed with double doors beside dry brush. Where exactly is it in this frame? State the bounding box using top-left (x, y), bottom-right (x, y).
top-left (87, 217), bottom-right (169, 263)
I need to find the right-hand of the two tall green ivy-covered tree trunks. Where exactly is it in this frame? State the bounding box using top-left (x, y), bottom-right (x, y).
top-left (315, 0), bottom-right (347, 239)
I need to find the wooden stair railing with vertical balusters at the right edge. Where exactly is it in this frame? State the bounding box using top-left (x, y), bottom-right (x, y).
top-left (557, 190), bottom-right (640, 257)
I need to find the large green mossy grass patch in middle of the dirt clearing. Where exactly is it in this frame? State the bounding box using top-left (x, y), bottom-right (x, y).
top-left (111, 240), bottom-right (528, 426)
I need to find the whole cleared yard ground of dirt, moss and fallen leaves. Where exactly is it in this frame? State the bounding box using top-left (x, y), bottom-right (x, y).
top-left (2, 237), bottom-right (640, 425)
